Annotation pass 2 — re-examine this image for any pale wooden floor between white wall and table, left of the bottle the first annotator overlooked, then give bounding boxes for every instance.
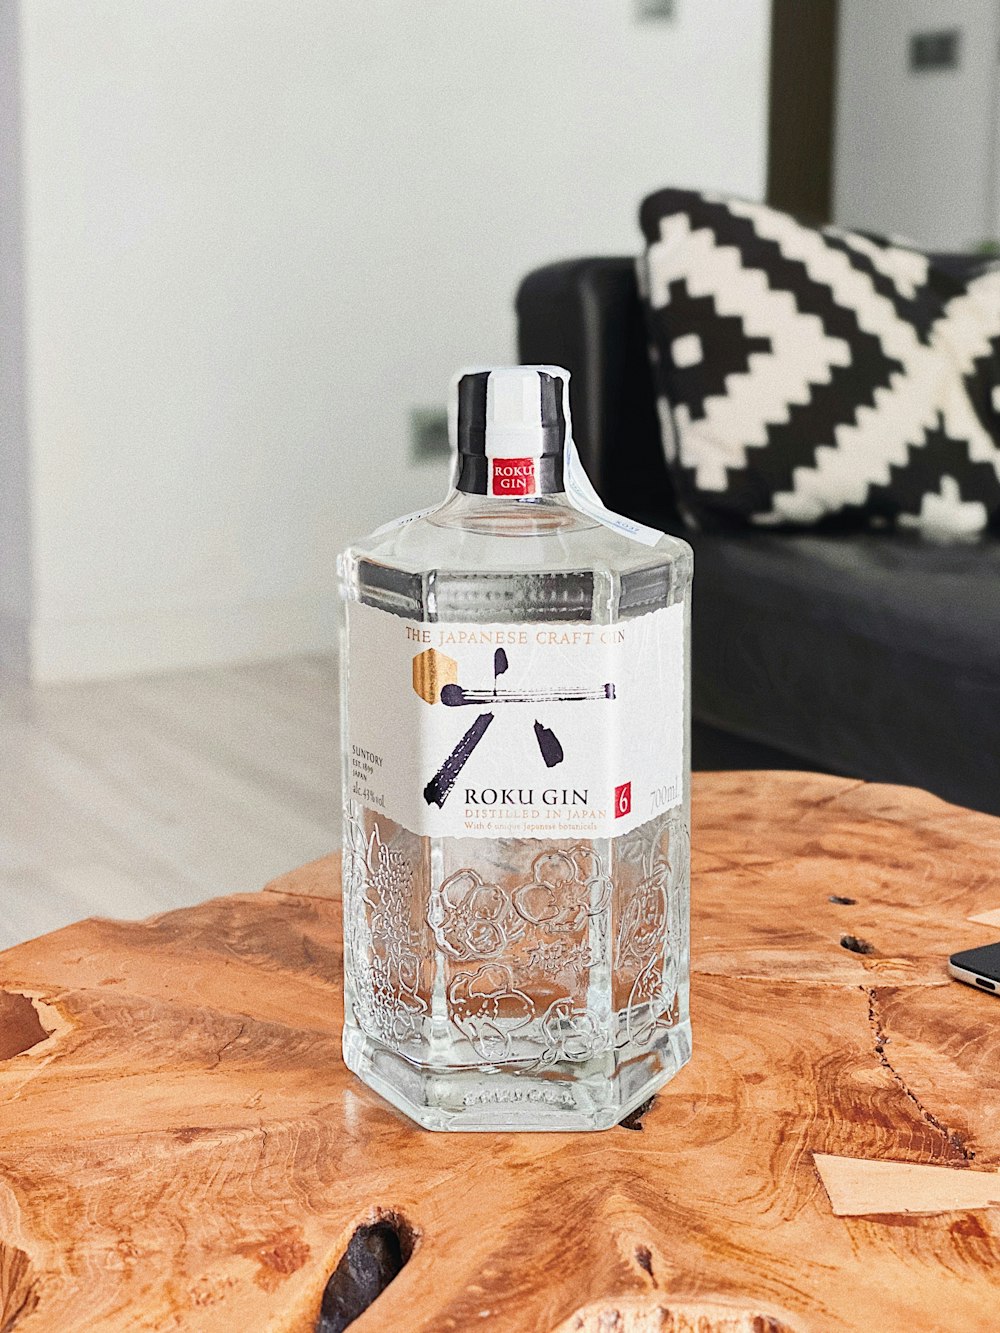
[0,657,340,949]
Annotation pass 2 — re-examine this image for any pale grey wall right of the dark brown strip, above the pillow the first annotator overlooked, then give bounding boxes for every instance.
[833,0,1000,251]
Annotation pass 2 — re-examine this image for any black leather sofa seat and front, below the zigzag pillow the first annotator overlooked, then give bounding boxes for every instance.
[692,532,1000,814]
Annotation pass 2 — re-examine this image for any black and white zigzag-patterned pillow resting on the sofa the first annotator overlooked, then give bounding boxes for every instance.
[640,189,1000,537]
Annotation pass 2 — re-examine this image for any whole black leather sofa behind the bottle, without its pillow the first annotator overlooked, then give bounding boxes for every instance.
[516,259,1000,814]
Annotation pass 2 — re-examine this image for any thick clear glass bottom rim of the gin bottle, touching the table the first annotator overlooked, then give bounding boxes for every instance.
[344,1022,691,1133]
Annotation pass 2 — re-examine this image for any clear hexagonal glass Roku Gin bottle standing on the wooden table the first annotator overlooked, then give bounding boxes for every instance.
[340,367,692,1130]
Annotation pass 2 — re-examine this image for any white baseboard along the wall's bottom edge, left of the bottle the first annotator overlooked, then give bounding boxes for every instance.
[31,592,336,684]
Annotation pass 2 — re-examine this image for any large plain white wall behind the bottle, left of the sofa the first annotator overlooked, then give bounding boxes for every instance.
[11,0,769,680]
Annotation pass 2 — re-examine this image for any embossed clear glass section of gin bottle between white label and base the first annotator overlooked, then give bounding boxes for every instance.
[345,810,689,1070]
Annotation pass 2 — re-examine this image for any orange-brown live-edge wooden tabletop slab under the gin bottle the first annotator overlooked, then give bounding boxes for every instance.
[0,773,1000,1333]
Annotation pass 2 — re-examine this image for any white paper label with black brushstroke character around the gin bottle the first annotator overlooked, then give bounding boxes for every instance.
[347,603,685,838]
